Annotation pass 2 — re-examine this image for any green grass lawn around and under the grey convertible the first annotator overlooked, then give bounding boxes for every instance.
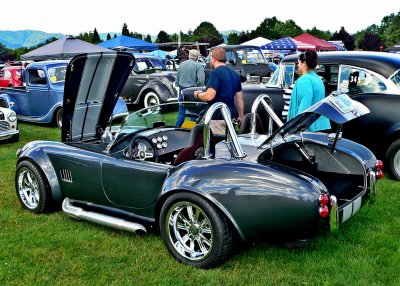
[0,123,400,286]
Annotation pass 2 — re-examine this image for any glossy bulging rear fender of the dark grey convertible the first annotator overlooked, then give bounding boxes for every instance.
[162,159,326,240]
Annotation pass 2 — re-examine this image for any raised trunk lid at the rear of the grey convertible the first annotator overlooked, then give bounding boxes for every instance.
[262,93,369,145]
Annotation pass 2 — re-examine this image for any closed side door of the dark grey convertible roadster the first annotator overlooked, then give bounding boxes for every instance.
[102,157,170,209]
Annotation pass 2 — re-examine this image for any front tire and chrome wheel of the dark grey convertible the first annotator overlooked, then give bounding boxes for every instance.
[15,160,52,214]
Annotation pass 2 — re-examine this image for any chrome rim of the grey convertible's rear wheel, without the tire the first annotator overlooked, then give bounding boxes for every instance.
[166,202,214,261]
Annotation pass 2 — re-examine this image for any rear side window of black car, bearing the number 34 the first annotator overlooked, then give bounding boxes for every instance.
[339,66,387,94]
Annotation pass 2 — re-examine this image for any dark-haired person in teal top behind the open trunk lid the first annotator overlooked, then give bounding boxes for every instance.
[287,50,331,132]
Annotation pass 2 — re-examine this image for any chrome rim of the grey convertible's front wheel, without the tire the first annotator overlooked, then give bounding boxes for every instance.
[17,168,40,209]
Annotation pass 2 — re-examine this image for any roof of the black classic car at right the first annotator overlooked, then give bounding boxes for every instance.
[282,51,400,78]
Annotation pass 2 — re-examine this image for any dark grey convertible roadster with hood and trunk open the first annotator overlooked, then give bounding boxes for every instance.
[15,50,382,268]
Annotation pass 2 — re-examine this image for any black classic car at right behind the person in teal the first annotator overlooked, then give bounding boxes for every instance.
[227,51,400,180]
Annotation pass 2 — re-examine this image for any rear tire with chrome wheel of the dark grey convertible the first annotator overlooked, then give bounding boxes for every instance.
[159,193,234,269]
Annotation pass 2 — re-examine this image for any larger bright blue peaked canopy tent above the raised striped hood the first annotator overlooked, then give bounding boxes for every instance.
[98,35,158,51]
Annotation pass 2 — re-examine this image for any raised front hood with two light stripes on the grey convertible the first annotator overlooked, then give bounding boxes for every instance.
[62,52,135,142]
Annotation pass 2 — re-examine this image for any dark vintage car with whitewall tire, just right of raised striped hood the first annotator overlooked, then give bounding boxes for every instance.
[121,54,178,107]
